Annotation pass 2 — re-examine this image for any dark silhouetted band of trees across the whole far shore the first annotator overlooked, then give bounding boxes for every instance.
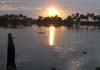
[0,13,100,29]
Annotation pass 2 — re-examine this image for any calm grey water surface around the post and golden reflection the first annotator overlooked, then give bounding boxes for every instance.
[0,26,100,70]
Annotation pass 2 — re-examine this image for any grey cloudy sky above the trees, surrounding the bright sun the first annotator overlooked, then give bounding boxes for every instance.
[0,0,100,18]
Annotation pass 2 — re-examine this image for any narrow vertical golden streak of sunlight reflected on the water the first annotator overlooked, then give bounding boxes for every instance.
[49,26,56,46]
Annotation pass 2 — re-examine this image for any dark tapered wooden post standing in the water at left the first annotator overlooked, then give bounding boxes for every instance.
[7,33,16,70]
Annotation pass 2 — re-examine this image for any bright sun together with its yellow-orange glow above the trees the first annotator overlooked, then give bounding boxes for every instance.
[41,6,71,18]
